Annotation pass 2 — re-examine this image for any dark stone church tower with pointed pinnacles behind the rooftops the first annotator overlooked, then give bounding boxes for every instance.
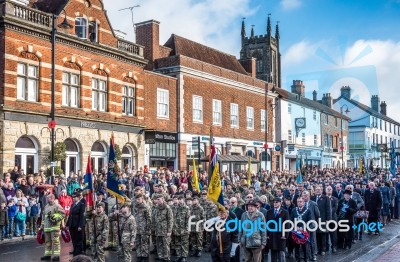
[240,15,281,87]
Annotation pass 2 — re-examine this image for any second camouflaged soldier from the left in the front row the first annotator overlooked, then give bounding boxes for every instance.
[109,203,136,262]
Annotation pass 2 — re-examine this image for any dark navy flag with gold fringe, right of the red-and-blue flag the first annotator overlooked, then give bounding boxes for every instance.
[107,134,125,203]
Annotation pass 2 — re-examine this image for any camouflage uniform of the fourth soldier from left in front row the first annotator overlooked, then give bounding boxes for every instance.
[152,203,174,261]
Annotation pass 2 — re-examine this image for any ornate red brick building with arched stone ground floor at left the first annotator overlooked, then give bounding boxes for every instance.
[0,0,176,174]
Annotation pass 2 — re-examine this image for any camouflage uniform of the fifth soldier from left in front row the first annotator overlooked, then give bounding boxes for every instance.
[173,203,190,258]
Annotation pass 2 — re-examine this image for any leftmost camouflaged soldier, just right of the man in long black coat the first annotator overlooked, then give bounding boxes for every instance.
[90,202,109,262]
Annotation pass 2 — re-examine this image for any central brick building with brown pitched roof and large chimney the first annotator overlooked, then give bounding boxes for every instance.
[136,20,277,170]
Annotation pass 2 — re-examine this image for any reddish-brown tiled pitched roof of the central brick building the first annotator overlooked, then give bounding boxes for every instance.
[164,34,247,75]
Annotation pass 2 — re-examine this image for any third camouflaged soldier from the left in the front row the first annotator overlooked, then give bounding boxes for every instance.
[133,194,151,262]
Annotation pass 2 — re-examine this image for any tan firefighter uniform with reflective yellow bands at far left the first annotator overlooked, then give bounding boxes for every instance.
[41,202,65,261]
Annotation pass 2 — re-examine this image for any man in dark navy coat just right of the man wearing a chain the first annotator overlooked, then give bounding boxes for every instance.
[311,186,332,256]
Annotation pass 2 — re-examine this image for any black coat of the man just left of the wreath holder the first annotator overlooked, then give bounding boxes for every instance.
[265,207,290,251]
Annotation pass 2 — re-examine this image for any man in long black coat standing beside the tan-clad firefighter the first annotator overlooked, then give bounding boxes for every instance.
[67,193,85,256]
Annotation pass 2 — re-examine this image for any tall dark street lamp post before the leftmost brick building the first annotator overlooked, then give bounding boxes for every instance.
[49,9,72,181]
